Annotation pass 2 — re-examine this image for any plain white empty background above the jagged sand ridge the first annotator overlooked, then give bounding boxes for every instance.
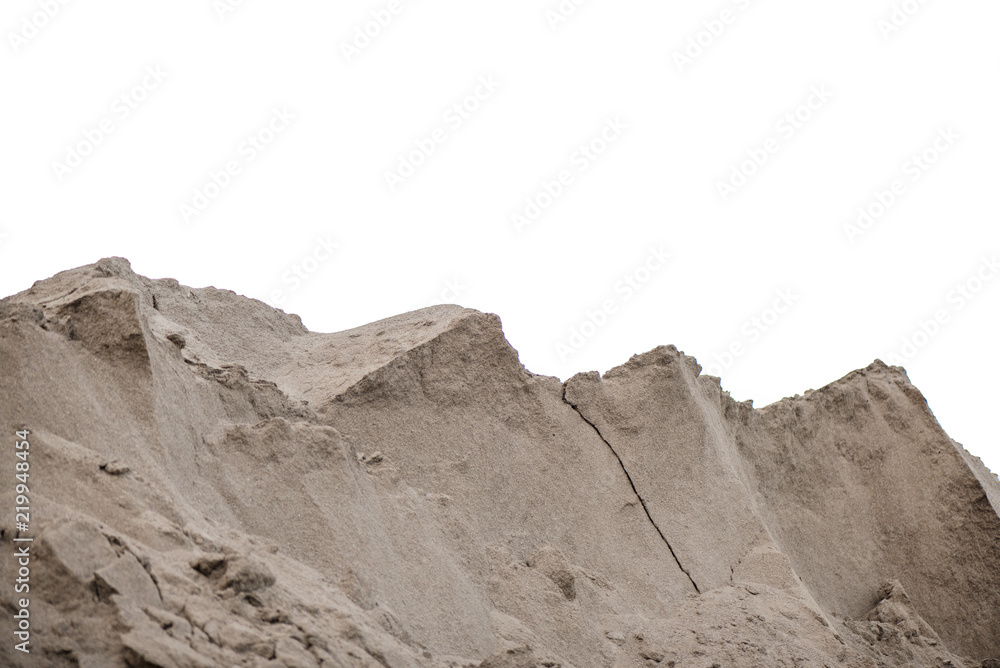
[0,0,1000,471]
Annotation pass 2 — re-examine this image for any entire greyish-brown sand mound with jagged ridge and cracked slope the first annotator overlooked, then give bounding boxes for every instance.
[0,258,1000,668]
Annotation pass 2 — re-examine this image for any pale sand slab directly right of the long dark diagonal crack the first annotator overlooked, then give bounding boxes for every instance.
[566,347,773,591]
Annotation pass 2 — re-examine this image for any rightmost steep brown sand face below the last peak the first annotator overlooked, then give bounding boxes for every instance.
[744,361,1000,656]
